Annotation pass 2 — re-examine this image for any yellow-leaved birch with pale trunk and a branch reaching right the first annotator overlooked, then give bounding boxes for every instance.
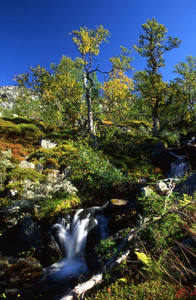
[72,25,132,137]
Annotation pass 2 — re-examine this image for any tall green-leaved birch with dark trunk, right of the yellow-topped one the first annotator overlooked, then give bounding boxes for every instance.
[134,18,181,136]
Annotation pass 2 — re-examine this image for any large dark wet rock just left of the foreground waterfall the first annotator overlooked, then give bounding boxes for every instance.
[0,216,61,267]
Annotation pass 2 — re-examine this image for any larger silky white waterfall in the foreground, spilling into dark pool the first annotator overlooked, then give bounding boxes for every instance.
[44,207,108,284]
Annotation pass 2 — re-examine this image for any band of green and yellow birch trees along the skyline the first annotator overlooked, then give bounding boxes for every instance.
[11,18,196,138]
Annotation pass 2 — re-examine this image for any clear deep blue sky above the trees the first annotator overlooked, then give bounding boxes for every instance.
[0,0,196,86]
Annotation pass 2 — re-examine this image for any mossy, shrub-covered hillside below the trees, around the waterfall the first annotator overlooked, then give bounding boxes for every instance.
[0,106,196,299]
